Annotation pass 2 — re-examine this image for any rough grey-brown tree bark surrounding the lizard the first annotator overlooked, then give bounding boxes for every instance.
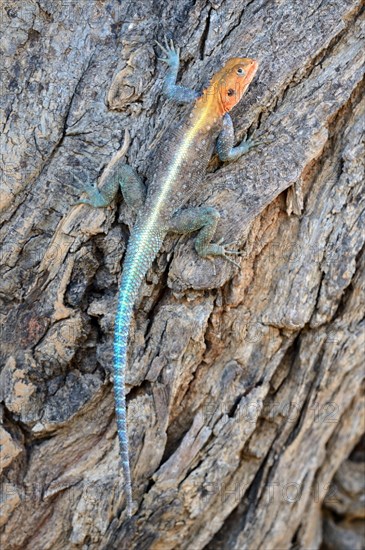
[0,0,364,550]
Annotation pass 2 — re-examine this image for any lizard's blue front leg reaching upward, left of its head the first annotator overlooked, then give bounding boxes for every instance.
[156,38,199,103]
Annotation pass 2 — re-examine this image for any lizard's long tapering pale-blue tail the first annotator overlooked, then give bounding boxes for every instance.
[114,227,163,517]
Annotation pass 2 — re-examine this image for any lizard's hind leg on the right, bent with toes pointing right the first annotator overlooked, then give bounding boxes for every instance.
[169,206,240,268]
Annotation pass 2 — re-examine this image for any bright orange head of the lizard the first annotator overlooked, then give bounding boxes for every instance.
[203,57,258,117]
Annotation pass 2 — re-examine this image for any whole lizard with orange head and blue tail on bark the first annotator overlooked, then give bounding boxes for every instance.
[78,37,260,517]
